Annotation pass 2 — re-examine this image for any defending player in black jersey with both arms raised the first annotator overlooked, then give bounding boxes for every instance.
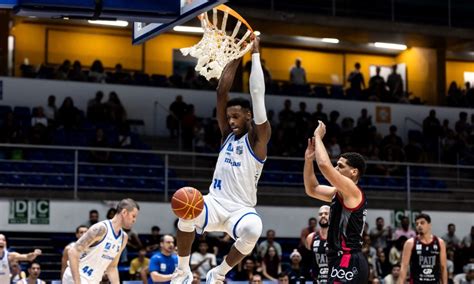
[304,121,369,284]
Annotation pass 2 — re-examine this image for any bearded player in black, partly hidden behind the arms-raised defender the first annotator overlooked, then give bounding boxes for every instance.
[306,205,330,284]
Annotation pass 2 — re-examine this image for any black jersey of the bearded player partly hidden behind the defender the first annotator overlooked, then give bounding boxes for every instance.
[311,234,329,284]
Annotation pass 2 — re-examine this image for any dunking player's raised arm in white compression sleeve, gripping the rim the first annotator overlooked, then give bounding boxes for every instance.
[249,37,272,160]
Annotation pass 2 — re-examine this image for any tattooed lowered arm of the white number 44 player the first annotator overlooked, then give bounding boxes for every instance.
[68,223,107,282]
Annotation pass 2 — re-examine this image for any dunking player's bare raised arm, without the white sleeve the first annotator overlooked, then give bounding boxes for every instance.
[216,59,240,141]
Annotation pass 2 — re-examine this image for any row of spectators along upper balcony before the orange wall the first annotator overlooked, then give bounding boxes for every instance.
[16,59,474,107]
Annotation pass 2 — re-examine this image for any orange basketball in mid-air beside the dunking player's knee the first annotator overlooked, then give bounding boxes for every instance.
[171,187,204,220]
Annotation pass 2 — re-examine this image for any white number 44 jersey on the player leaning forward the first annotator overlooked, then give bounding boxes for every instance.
[74,220,124,283]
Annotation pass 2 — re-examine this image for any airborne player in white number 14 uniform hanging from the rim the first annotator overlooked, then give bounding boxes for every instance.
[171,38,271,284]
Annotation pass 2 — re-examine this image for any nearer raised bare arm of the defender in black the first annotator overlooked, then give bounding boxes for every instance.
[314,121,362,207]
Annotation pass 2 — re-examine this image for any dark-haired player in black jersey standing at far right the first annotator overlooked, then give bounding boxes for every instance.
[398,214,448,284]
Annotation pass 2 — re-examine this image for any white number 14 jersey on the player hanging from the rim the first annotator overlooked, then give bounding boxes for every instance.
[209,133,265,211]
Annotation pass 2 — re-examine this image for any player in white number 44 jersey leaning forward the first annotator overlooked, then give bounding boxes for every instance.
[62,199,140,284]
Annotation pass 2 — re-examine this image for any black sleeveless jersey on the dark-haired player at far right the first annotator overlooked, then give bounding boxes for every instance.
[410,236,441,284]
